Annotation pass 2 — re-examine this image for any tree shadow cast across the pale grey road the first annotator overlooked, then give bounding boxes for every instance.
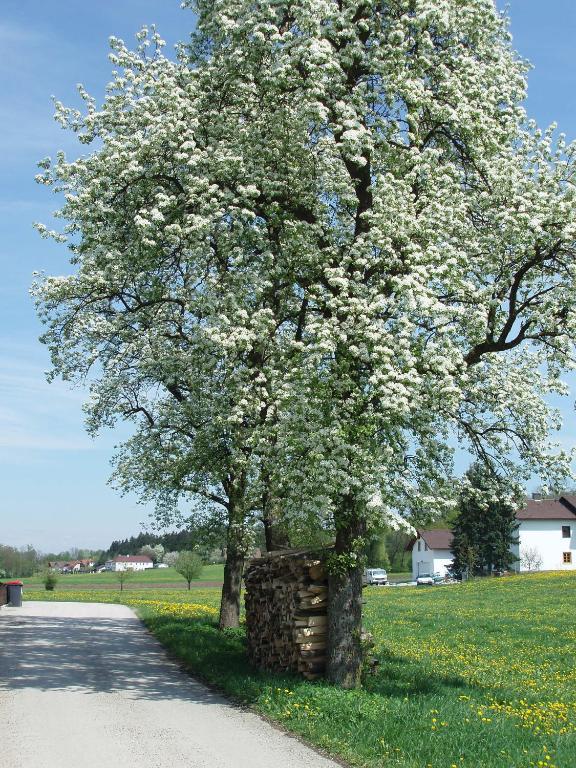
[0,612,222,704]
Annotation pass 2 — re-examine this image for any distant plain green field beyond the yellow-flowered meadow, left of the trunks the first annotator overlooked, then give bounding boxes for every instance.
[22,564,224,590]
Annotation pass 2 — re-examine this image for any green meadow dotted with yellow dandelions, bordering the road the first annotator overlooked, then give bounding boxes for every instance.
[20,573,576,768]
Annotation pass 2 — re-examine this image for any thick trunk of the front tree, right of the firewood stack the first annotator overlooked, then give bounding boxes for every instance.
[326,499,365,688]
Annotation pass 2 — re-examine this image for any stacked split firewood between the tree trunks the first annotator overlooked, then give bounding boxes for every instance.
[244,550,328,680]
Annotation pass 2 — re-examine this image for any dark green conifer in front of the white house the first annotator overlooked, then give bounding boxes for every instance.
[452,462,520,576]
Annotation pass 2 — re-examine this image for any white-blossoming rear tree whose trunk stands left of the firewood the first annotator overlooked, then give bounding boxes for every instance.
[35,31,298,627]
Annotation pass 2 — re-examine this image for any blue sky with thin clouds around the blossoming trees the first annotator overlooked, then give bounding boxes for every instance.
[0,0,576,551]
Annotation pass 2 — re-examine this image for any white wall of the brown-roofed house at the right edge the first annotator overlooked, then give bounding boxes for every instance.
[512,518,576,571]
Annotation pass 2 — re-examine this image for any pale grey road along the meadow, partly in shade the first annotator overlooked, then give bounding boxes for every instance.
[0,602,337,768]
